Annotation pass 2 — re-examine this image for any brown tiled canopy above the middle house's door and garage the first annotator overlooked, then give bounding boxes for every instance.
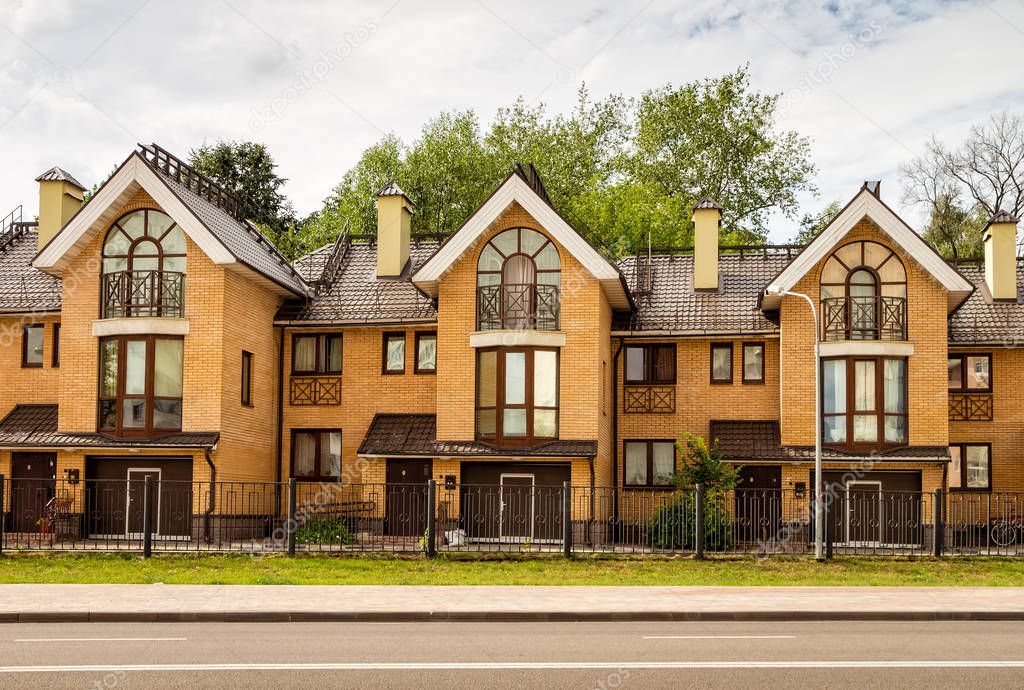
[357,414,597,458]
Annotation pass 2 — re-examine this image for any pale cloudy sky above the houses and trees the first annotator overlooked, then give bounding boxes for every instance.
[0,0,1024,242]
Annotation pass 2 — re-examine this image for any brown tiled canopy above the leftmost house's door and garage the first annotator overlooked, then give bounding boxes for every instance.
[0,404,220,448]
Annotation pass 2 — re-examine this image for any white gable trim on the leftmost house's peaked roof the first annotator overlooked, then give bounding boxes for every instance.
[32,154,237,274]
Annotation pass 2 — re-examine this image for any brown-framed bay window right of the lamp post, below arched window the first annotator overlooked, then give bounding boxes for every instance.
[821,357,907,450]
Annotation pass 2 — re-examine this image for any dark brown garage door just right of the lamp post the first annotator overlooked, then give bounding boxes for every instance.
[811,464,924,546]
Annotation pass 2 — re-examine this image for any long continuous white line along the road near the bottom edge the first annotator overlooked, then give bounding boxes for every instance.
[0,659,1024,674]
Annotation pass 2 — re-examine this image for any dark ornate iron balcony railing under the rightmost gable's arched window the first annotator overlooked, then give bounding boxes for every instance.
[821,296,906,341]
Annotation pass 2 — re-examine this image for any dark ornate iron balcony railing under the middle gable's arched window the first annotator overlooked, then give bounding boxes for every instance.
[476,284,561,331]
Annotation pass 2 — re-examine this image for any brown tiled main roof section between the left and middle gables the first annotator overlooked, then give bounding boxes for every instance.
[278,242,439,324]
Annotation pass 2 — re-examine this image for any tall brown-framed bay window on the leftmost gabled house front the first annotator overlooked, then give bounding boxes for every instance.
[98,336,184,437]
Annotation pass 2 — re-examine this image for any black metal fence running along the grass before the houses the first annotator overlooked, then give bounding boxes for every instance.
[0,472,1024,556]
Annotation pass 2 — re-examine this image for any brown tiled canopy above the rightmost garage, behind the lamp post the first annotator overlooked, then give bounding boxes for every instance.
[711,420,949,462]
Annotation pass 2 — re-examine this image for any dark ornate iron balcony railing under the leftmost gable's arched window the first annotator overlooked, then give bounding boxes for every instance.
[102,270,185,318]
